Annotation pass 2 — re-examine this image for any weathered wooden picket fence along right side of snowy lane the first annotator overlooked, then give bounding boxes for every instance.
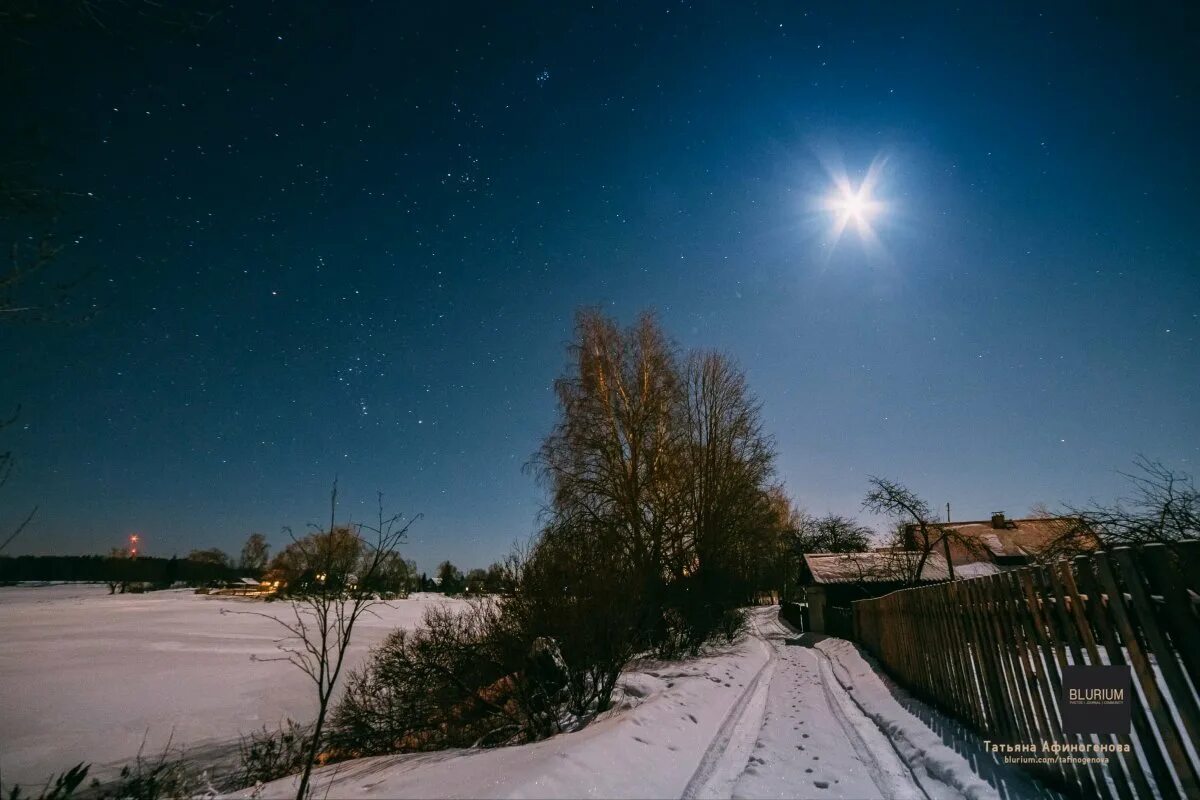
[853,542,1200,800]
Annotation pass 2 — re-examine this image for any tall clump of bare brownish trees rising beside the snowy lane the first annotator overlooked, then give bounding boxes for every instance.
[530,309,784,642]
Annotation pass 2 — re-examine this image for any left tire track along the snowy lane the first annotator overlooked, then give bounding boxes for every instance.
[682,614,779,800]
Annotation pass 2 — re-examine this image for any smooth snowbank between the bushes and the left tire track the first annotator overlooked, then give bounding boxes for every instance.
[224,638,768,799]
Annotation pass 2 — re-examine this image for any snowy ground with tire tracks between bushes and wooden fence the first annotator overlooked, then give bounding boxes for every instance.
[225,607,1052,800]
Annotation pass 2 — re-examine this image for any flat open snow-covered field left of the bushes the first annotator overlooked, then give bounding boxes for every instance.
[0,584,462,784]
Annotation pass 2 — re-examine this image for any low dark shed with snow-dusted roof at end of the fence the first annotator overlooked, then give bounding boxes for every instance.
[799,548,950,636]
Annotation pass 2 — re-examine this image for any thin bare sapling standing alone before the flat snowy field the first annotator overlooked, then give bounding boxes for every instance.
[229,481,421,800]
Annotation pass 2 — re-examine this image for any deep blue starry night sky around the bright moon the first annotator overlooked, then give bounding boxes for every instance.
[0,1,1200,569]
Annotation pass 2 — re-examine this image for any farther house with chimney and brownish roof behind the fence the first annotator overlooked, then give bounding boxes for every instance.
[904,511,1099,578]
